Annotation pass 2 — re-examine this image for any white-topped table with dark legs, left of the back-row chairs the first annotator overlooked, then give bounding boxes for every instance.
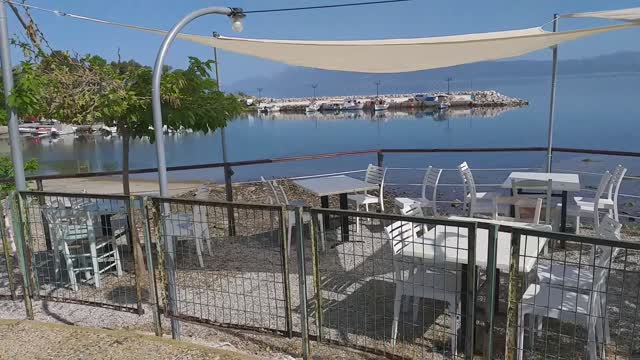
[294,175,378,241]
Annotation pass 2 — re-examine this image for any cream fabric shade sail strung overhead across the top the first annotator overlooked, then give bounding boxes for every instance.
[66,8,640,73]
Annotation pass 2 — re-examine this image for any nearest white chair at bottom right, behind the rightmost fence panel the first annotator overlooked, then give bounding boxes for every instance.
[518,215,622,359]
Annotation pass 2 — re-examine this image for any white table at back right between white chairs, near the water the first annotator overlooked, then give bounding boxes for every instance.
[502,172,580,232]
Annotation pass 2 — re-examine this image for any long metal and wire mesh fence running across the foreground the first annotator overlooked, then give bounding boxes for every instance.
[0,192,640,359]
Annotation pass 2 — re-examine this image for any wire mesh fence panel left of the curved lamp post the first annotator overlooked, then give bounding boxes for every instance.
[21,192,142,311]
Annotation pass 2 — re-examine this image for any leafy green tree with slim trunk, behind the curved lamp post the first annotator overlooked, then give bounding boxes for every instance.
[0,42,243,193]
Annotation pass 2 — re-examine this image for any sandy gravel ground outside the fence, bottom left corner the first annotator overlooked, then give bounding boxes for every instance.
[0,320,255,360]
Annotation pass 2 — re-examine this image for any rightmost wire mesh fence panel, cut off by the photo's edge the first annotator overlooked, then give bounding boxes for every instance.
[508,225,640,359]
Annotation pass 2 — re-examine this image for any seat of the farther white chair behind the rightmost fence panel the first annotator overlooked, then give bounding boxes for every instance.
[537,262,593,291]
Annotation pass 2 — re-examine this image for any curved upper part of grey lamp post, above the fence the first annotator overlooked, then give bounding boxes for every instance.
[151,7,243,196]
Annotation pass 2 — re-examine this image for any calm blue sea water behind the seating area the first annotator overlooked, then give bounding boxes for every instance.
[0,74,640,191]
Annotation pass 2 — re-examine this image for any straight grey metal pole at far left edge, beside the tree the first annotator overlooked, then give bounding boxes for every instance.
[0,4,27,191]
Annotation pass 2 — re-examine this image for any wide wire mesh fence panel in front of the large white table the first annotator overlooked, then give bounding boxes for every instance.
[307,209,476,359]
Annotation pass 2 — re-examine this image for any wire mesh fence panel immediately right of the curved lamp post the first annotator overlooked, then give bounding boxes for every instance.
[153,198,294,332]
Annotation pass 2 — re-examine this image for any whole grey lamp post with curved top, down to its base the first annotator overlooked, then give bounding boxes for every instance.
[150,7,245,339]
